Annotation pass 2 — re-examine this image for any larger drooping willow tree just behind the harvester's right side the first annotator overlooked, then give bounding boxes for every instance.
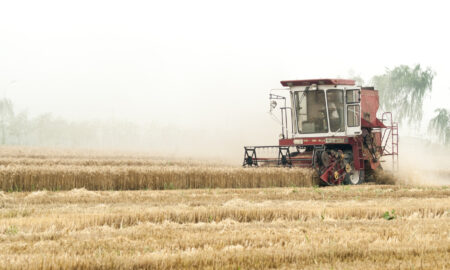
[372,65,435,124]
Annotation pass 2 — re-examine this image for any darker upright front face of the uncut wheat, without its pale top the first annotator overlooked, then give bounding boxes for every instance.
[0,165,314,191]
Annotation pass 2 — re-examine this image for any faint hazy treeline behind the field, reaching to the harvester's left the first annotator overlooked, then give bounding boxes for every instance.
[0,98,243,161]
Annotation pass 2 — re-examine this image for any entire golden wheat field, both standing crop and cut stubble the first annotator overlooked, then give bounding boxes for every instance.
[0,148,450,269]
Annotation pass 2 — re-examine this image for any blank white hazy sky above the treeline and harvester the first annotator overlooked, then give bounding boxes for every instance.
[0,0,450,131]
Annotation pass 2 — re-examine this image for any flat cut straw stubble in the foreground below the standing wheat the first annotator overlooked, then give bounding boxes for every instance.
[0,186,450,269]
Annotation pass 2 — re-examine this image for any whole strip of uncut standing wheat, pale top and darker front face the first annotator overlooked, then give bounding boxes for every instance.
[0,148,316,191]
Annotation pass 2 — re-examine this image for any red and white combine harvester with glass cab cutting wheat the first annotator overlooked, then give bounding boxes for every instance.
[243,79,398,185]
